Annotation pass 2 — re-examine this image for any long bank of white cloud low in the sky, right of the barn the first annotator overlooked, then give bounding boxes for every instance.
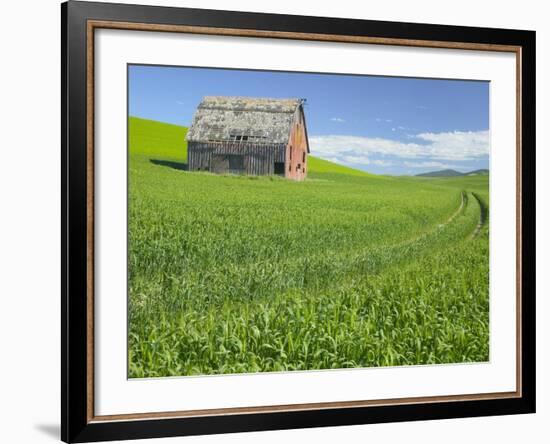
[309,131,489,161]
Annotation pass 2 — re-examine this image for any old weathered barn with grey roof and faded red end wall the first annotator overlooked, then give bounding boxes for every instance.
[187,96,309,180]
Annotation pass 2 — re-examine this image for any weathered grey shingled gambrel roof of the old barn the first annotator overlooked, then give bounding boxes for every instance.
[187,96,304,144]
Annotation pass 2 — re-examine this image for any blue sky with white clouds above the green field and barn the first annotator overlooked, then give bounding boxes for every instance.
[129,65,489,174]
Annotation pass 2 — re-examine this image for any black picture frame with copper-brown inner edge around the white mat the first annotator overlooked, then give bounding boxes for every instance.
[61,1,536,442]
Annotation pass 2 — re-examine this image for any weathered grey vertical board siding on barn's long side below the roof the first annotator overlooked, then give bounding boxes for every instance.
[187,142,285,176]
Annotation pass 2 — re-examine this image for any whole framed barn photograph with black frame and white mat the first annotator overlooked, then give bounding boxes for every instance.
[61,1,535,442]
